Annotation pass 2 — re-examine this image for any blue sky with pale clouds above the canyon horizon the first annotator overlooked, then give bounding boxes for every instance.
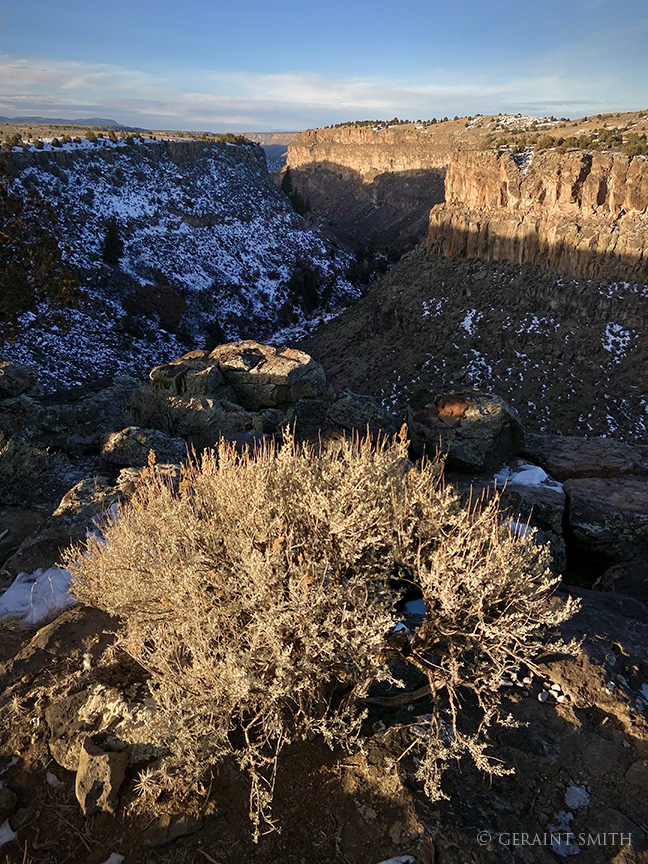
[0,0,648,132]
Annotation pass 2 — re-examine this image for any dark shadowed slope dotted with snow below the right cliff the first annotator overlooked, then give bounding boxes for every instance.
[302,247,648,442]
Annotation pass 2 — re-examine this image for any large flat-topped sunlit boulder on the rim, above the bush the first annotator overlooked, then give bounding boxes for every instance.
[209,340,333,411]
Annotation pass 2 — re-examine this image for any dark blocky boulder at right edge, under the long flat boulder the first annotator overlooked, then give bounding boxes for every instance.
[565,476,648,566]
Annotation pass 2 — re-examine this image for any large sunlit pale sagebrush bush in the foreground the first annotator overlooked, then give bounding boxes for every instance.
[68,430,571,836]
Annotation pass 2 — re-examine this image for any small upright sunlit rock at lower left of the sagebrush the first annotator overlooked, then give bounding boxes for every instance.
[74,737,128,816]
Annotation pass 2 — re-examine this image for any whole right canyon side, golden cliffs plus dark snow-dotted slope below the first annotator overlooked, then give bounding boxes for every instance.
[287,118,648,440]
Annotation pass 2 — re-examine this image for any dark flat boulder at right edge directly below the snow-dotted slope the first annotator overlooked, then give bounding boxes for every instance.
[524,435,648,483]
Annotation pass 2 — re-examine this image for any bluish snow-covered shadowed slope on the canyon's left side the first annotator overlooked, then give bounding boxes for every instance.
[3,139,356,386]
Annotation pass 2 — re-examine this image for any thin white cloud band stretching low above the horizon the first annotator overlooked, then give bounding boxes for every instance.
[0,55,640,130]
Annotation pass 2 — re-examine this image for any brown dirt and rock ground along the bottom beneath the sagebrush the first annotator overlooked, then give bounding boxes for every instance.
[0,589,648,864]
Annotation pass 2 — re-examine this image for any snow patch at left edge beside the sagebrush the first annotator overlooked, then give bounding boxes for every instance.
[0,567,76,626]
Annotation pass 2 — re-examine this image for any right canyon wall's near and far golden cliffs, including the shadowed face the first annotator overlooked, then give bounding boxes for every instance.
[283,123,648,282]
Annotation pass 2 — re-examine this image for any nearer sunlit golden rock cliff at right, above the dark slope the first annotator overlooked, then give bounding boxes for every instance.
[427,150,648,282]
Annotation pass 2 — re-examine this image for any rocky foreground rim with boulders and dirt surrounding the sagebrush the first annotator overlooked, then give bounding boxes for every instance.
[0,342,648,864]
